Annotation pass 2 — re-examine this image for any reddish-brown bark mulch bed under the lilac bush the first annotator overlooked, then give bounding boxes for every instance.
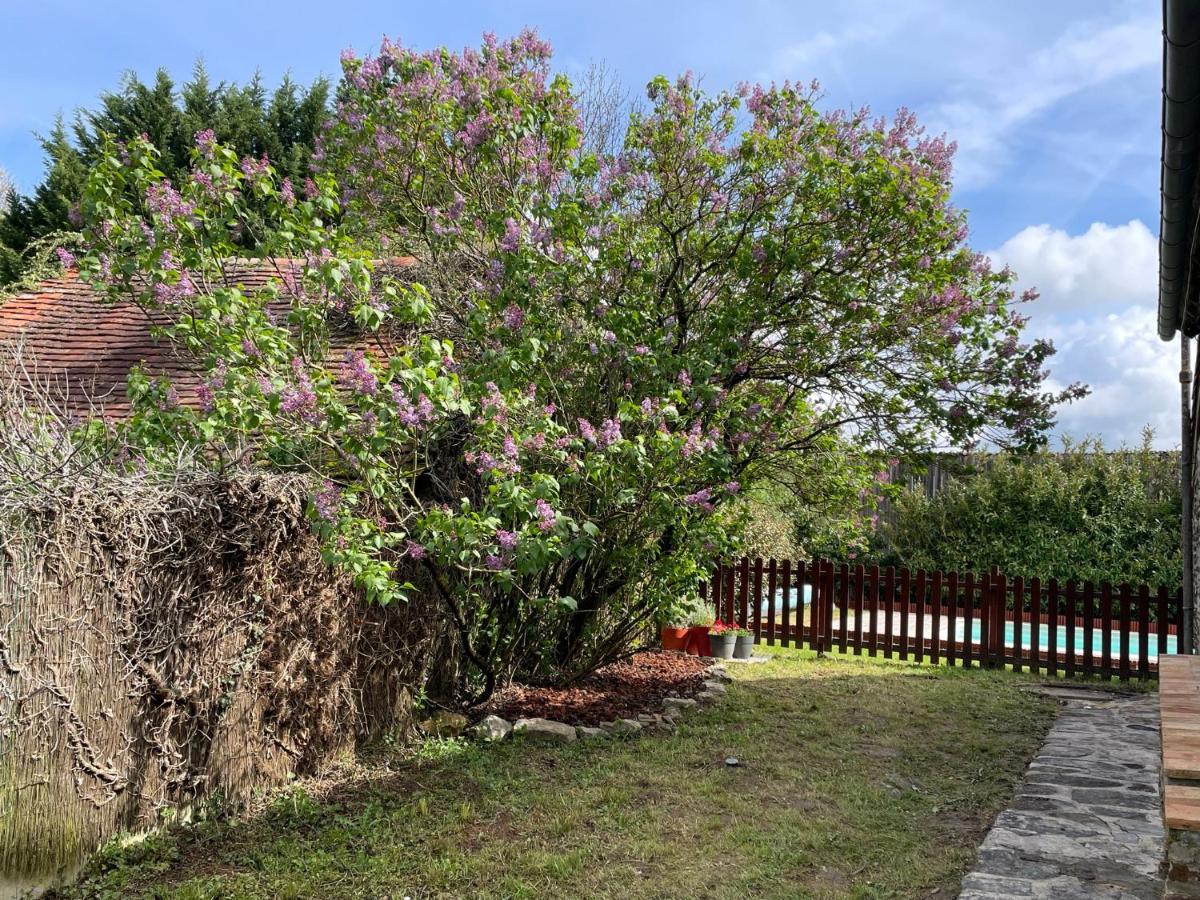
[486,653,712,726]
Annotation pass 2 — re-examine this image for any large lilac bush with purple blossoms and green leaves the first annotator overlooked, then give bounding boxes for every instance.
[80,32,1081,700]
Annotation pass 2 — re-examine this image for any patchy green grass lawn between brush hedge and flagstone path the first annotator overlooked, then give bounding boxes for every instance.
[58,649,1054,900]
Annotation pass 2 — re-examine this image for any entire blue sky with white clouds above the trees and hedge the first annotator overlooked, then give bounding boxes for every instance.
[0,0,1178,445]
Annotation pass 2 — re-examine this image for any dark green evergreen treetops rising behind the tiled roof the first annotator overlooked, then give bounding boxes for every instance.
[0,62,330,284]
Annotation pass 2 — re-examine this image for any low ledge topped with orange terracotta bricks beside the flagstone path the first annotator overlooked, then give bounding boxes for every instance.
[1158,655,1200,898]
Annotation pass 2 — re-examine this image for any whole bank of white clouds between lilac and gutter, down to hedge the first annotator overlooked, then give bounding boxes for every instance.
[989,220,1180,448]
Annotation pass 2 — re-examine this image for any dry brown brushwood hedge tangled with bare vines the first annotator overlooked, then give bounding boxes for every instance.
[0,352,452,878]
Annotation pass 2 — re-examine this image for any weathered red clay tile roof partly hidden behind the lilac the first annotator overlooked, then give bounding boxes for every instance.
[0,257,415,418]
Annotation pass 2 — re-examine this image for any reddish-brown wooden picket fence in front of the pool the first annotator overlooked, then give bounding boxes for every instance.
[701,559,1183,680]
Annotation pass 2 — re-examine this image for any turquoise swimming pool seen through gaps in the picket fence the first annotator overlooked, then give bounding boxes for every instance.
[760,584,1178,660]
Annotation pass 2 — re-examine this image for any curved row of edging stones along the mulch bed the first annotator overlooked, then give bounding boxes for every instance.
[470,662,733,744]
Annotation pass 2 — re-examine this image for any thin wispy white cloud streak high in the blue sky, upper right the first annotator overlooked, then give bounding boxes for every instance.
[930,17,1162,188]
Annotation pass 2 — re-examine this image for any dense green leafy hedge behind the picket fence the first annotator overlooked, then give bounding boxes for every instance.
[877,432,1183,588]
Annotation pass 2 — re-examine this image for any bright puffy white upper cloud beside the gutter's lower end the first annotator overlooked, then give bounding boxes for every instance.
[989,218,1158,313]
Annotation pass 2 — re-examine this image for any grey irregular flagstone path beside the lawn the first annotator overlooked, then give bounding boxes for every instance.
[959,691,1164,900]
